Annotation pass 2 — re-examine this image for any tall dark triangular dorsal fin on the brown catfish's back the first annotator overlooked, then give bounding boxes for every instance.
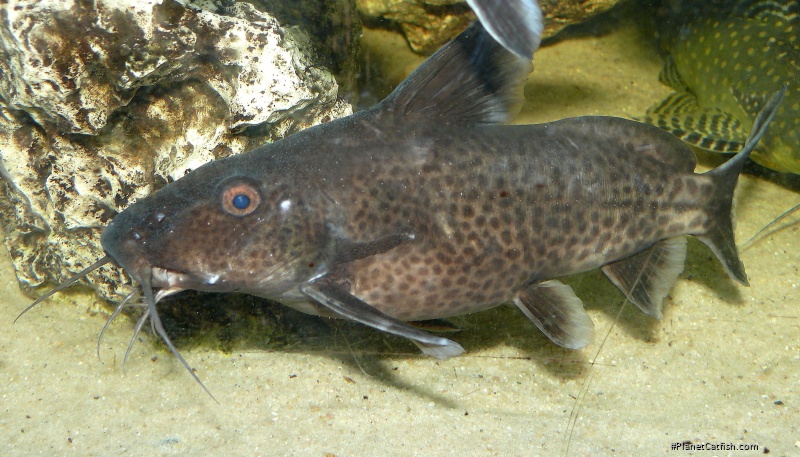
[375,22,531,125]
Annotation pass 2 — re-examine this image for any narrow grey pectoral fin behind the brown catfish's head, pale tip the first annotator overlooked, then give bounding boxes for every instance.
[300,278,464,360]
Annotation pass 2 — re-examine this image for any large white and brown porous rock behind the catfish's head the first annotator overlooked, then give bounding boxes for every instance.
[0,0,360,300]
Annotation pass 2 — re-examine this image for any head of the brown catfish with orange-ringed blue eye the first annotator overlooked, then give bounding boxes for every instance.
[101,146,335,301]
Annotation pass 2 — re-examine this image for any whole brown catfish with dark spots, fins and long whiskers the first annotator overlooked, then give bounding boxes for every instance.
[18,14,783,392]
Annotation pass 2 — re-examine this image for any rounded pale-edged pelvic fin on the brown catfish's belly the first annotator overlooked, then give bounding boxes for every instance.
[513,280,594,349]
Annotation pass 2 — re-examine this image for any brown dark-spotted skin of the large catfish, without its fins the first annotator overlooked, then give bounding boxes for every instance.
[106,116,692,306]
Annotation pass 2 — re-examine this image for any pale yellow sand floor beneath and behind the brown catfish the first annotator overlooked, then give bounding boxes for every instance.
[0,16,800,457]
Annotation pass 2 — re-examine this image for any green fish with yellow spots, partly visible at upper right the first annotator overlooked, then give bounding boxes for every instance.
[645,0,800,173]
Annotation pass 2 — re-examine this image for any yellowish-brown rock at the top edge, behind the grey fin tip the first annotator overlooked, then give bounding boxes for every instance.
[356,0,621,55]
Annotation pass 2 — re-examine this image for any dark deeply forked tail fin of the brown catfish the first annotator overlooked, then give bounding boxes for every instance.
[698,86,786,286]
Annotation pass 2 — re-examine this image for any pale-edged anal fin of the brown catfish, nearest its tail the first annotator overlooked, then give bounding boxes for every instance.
[601,236,686,319]
